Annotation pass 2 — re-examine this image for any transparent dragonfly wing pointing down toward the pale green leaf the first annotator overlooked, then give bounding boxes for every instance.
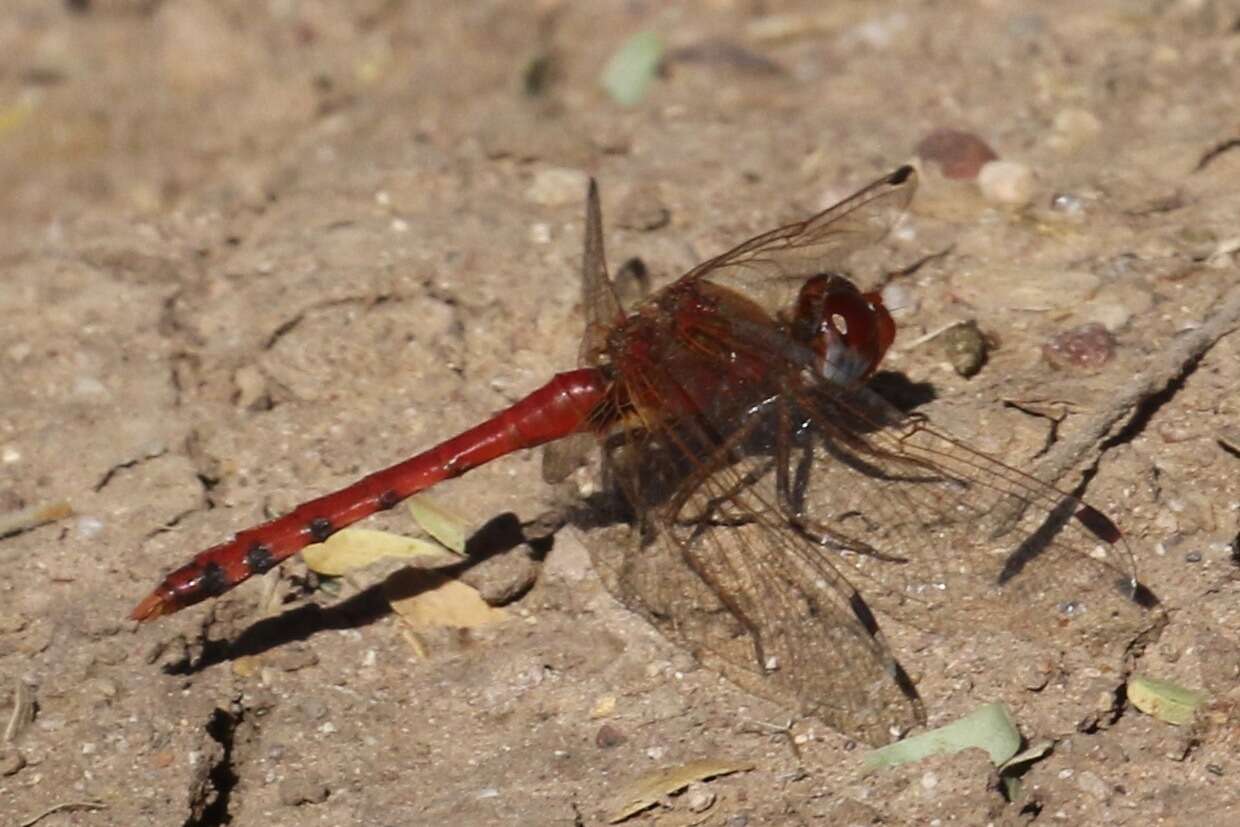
[591,389,925,744]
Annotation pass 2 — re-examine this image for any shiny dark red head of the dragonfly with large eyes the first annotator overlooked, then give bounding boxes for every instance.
[792,273,895,387]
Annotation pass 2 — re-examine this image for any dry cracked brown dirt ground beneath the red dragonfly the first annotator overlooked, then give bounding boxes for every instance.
[0,0,1240,827]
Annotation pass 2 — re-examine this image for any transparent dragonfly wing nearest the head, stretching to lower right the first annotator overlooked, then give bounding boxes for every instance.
[789,386,1149,642]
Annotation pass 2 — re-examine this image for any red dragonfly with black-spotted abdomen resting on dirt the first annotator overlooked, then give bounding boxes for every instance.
[131,166,1152,743]
